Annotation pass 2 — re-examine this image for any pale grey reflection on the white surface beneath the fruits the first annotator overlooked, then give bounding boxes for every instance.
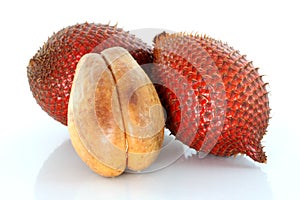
[35,140,272,200]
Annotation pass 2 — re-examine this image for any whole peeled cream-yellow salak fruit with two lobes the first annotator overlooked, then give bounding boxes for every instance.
[68,47,164,177]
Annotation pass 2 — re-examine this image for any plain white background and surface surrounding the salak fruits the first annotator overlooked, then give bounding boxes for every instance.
[0,0,300,199]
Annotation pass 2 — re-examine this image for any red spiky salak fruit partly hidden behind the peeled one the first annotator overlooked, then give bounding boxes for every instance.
[27,23,152,125]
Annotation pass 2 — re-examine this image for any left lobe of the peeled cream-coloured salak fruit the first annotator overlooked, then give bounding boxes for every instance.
[68,54,126,176]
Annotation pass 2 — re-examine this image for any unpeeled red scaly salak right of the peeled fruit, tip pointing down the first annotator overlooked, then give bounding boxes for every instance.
[149,33,270,163]
